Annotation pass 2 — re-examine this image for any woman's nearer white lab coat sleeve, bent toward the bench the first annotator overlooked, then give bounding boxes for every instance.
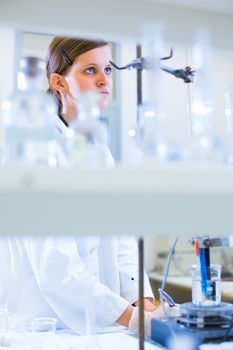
[24,237,129,334]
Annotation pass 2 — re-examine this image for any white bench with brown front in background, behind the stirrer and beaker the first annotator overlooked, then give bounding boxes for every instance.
[148,272,233,304]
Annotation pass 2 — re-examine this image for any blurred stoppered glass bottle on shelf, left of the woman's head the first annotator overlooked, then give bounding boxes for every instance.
[1,57,57,167]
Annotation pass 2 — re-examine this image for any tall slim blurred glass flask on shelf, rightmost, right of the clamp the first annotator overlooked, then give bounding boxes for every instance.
[190,29,226,163]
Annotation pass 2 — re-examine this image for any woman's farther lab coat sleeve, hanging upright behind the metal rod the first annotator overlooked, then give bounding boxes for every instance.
[118,237,154,304]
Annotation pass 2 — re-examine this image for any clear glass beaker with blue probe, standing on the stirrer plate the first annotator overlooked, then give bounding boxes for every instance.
[192,264,222,306]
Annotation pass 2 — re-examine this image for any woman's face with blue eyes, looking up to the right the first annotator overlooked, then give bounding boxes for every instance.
[65,45,112,109]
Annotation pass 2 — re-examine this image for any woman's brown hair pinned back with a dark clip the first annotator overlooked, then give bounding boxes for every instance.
[46,36,108,120]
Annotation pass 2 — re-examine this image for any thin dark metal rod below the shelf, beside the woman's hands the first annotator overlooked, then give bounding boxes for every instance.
[138,238,145,350]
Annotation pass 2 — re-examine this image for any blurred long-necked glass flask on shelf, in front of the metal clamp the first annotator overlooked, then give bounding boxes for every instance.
[129,23,182,166]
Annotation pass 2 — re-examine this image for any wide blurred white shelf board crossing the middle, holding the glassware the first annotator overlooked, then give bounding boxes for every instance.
[0,164,233,236]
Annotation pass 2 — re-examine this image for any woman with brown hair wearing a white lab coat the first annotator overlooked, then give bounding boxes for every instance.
[4,37,177,335]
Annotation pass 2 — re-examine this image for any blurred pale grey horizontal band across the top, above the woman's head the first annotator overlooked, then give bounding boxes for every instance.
[0,0,233,48]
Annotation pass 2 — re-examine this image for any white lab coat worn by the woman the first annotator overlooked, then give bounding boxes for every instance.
[0,114,156,334]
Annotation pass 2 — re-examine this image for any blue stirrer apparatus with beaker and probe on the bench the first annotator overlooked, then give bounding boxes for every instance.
[151,236,233,348]
